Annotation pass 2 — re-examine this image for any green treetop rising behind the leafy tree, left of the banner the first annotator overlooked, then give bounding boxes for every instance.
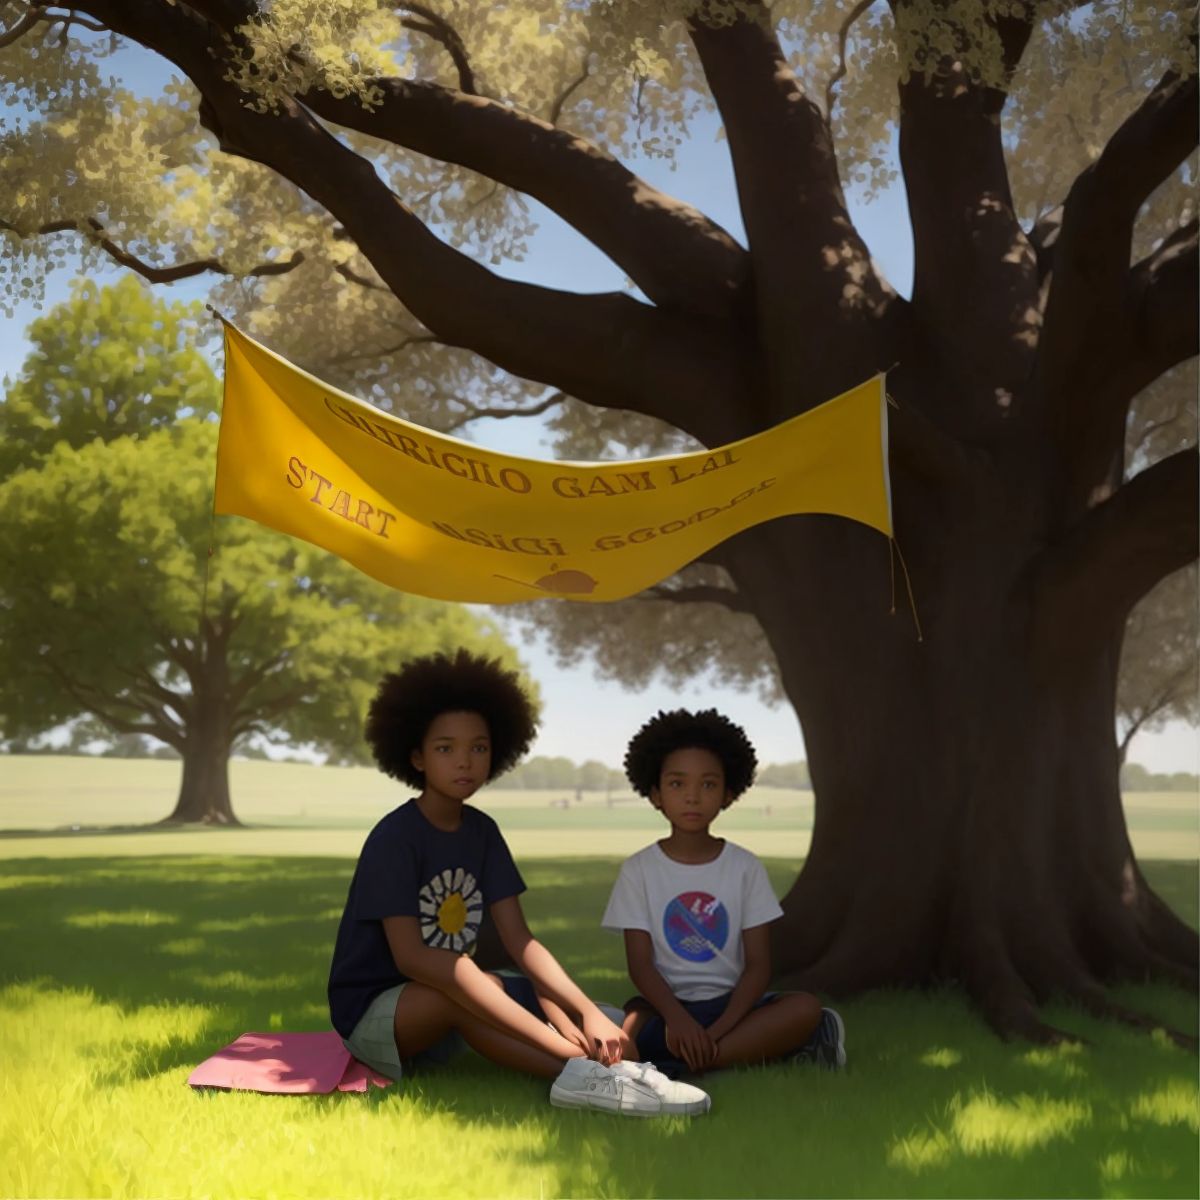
[0,275,220,479]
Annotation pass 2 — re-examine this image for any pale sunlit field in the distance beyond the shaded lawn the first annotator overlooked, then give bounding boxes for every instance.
[0,755,1200,860]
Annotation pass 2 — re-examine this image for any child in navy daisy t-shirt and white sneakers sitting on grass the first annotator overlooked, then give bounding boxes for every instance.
[329,650,709,1116]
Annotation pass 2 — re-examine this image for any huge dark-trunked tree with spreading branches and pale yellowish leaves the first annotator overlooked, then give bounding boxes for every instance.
[0,0,1198,1039]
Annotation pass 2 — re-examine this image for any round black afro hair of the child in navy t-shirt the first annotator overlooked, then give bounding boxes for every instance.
[366,650,538,787]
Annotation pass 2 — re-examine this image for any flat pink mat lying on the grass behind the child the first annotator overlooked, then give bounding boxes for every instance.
[187,1030,391,1096]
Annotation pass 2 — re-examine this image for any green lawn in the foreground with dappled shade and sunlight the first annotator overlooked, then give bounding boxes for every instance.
[0,854,1200,1198]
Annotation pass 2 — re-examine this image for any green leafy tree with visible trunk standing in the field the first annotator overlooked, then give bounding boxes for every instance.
[0,421,525,824]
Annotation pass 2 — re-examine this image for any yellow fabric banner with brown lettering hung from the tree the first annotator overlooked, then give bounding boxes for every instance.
[216,325,892,604]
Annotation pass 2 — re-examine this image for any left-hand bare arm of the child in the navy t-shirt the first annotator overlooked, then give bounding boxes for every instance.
[383,917,578,1058]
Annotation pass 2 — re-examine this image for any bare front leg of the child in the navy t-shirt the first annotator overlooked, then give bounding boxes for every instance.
[392,983,582,1079]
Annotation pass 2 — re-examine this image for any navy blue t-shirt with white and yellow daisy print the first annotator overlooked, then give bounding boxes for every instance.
[329,800,524,1038]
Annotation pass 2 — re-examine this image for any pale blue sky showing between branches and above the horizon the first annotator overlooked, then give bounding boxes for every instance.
[0,37,1200,772]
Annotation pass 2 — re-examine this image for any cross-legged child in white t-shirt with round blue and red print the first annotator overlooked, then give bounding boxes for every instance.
[604,709,846,1072]
